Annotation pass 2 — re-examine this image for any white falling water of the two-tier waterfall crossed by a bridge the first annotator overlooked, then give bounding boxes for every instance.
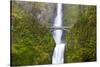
[52,3,65,64]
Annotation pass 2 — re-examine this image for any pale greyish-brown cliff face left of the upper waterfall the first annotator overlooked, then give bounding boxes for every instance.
[16,1,56,27]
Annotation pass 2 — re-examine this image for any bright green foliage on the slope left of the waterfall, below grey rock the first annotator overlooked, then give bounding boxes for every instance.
[11,2,54,66]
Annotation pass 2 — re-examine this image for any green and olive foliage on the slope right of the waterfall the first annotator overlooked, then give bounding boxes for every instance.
[65,6,96,62]
